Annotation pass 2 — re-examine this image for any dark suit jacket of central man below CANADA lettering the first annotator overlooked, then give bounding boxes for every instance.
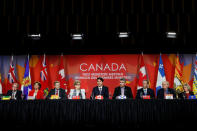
[90,86,109,99]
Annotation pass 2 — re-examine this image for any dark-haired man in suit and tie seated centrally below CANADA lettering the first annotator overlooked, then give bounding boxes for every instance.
[90,77,109,99]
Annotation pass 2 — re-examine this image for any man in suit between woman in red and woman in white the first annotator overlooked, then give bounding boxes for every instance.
[47,81,67,99]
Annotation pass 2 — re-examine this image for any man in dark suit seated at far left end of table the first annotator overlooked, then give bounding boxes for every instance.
[6,82,22,100]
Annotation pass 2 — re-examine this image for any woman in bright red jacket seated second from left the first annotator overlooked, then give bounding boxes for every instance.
[28,82,44,100]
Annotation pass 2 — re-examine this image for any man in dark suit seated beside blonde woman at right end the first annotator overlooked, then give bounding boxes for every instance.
[157,81,176,99]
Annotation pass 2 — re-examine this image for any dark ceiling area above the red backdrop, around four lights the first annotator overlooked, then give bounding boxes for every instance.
[0,0,197,54]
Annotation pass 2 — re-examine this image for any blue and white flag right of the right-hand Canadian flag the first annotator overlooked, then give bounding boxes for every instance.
[156,55,166,95]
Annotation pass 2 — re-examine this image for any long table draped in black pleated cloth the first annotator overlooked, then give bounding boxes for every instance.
[0,100,197,128]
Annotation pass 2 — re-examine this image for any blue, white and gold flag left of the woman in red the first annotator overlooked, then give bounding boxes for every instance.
[21,56,32,99]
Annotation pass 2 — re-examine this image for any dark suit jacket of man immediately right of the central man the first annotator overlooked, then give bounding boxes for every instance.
[113,86,133,99]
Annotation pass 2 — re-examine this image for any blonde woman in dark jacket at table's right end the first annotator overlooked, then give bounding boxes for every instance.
[178,83,194,99]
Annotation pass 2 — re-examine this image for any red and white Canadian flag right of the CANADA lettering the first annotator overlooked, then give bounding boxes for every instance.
[137,55,147,89]
